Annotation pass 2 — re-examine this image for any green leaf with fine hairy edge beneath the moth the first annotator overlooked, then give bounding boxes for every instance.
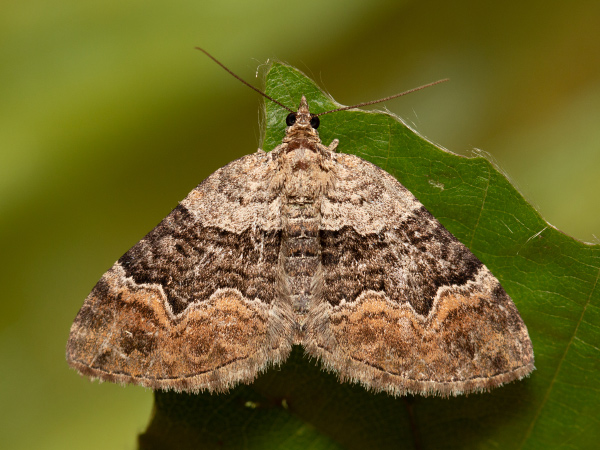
[140,64,600,449]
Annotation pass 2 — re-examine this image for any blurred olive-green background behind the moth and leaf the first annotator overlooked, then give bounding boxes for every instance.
[0,0,600,449]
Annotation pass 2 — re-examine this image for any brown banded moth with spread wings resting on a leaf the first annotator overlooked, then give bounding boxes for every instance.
[67,50,534,396]
